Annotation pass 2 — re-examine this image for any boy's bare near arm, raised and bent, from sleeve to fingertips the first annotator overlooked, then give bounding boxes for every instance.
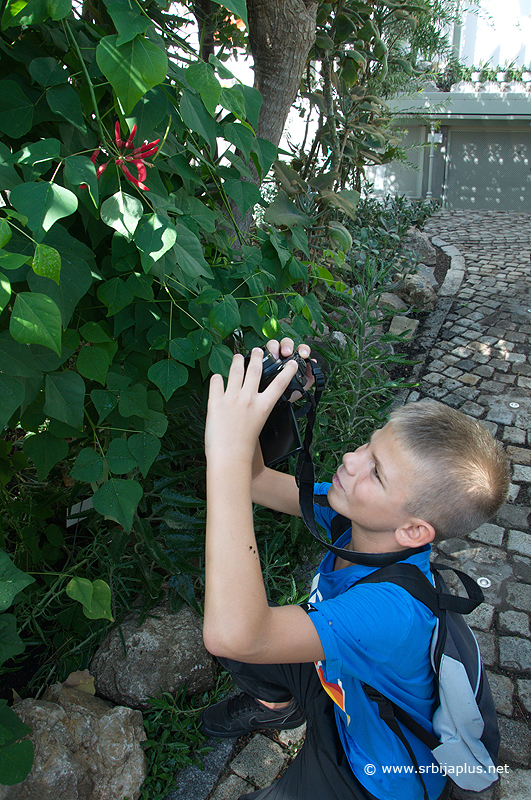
[203,350,324,663]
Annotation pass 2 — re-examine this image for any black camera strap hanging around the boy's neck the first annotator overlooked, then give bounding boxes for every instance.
[295,361,424,567]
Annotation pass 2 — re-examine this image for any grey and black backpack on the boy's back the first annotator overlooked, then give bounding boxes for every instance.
[358,563,500,800]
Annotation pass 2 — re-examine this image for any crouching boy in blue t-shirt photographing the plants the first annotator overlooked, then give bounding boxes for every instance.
[202,339,508,800]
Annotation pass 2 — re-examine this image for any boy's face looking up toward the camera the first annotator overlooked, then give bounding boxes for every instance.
[328,425,415,534]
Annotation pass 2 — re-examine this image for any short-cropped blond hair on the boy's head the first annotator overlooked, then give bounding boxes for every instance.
[389,400,510,539]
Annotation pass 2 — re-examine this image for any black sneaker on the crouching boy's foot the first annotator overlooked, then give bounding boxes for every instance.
[201,693,304,737]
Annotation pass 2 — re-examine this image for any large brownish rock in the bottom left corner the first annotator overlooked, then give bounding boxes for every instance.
[0,684,147,800]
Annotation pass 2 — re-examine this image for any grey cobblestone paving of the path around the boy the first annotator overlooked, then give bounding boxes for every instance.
[167,211,531,800]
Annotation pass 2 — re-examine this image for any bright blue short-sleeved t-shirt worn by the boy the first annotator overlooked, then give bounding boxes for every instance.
[309,483,446,800]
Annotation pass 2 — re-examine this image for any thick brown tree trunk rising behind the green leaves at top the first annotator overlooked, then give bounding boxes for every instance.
[247,0,318,145]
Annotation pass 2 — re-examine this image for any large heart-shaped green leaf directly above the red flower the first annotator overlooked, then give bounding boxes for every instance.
[96,36,168,114]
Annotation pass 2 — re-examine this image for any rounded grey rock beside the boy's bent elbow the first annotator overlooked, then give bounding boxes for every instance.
[90,601,214,709]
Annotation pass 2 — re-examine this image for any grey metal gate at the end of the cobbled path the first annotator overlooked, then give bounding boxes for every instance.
[444,127,531,211]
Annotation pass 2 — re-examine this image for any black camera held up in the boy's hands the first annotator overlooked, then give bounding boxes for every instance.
[245,347,307,467]
